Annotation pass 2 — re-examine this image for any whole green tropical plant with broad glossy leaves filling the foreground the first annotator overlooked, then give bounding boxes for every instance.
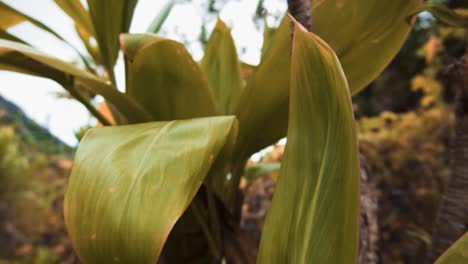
[0,0,464,263]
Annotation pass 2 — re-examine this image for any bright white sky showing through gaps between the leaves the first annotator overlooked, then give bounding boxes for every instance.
[0,0,287,146]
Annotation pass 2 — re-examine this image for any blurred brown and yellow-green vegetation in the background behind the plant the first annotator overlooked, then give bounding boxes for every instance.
[0,1,464,264]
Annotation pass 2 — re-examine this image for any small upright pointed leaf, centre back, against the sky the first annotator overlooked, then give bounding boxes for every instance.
[201,19,243,115]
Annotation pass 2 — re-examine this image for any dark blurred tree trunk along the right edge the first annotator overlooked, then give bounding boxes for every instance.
[426,38,468,263]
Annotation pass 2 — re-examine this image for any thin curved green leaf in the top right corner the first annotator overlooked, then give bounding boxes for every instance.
[409,1,468,28]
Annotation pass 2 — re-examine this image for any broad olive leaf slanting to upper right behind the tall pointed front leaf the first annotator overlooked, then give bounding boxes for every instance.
[236,0,421,161]
